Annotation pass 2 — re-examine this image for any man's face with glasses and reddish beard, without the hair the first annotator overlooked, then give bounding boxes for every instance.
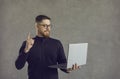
[37,19,51,37]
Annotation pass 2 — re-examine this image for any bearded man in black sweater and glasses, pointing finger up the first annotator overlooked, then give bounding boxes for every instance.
[15,15,79,79]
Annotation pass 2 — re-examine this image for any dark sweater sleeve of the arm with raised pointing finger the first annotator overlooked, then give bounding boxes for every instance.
[15,41,29,70]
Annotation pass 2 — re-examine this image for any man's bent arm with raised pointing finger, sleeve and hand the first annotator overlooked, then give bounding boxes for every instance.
[15,33,34,69]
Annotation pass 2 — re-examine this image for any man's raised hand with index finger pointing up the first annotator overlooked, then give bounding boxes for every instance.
[24,33,34,53]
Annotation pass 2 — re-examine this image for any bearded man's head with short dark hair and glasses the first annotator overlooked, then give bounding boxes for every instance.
[35,15,51,37]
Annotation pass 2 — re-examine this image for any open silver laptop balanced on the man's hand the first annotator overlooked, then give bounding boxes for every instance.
[49,43,88,69]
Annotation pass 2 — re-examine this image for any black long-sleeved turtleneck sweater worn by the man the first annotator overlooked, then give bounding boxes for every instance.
[15,36,67,79]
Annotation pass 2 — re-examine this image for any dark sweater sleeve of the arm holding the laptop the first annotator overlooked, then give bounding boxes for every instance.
[57,41,69,73]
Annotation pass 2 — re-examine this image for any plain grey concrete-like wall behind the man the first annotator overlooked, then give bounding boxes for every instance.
[0,0,120,79]
